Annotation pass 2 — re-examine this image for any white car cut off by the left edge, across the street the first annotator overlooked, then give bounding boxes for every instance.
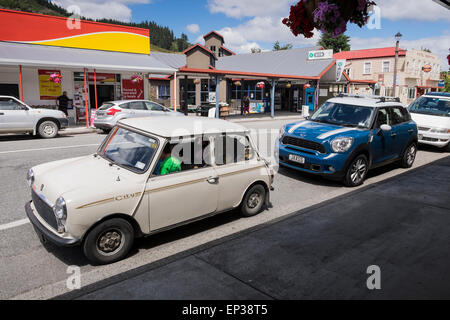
[0,96,69,138]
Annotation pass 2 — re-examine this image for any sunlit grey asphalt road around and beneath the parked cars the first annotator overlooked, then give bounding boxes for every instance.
[0,120,448,299]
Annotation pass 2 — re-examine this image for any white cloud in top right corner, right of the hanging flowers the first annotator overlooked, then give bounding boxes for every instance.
[375,0,450,21]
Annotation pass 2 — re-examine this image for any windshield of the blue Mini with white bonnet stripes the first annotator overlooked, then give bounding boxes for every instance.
[311,102,374,128]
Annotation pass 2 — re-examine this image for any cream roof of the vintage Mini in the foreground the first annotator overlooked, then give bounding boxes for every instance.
[120,116,248,138]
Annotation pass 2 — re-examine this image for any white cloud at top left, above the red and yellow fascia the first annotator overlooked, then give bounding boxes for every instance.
[52,0,151,22]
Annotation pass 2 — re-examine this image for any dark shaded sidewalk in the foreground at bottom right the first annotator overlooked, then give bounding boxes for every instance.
[57,157,450,300]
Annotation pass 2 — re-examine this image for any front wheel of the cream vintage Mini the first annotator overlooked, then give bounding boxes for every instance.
[83,218,134,264]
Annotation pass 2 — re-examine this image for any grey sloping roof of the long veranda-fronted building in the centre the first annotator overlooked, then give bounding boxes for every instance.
[216,47,334,78]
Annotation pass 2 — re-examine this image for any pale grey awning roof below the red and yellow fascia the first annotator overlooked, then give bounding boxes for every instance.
[0,41,176,74]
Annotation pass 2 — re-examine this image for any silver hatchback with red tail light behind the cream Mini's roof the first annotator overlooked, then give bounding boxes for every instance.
[94,100,184,132]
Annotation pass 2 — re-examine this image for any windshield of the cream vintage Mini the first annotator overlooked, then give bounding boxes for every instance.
[99,128,158,173]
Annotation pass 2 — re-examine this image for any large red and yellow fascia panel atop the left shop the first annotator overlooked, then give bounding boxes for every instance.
[0,9,150,54]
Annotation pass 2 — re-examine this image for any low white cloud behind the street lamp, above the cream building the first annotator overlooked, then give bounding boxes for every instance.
[351,33,450,70]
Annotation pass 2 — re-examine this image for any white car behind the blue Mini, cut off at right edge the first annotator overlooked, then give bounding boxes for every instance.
[409,92,450,151]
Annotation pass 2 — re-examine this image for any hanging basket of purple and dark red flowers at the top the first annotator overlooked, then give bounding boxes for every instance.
[282,0,375,38]
